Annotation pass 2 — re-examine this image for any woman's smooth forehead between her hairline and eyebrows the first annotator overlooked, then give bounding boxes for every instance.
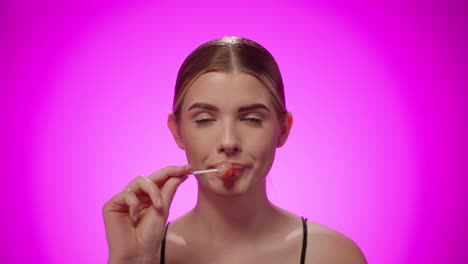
[182,72,273,110]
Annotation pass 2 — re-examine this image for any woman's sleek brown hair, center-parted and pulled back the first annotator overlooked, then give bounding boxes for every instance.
[173,37,287,119]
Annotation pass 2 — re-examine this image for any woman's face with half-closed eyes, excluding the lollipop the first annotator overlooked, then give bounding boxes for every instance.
[169,72,290,195]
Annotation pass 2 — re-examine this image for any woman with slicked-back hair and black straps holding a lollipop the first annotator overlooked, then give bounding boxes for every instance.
[103,37,366,264]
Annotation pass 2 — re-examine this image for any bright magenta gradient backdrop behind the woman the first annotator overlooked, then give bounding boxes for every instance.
[0,0,467,263]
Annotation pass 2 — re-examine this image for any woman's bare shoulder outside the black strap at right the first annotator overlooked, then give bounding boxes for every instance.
[306,221,367,264]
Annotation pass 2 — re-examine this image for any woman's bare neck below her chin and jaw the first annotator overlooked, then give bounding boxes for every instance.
[193,179,277,241]
